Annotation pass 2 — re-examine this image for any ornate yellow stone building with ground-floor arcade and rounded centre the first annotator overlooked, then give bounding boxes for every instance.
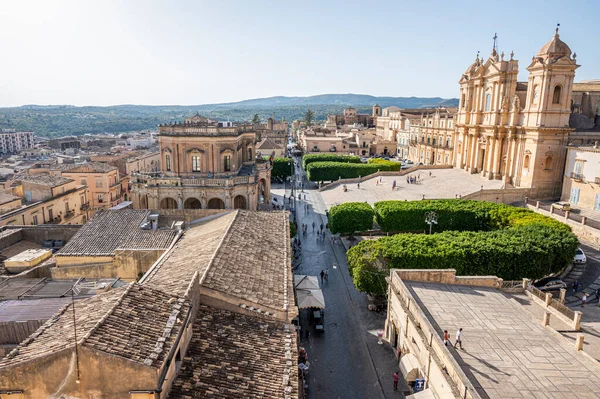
[131,115,271,210]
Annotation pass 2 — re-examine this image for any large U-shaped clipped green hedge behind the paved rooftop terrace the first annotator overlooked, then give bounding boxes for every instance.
[347,200,579,295]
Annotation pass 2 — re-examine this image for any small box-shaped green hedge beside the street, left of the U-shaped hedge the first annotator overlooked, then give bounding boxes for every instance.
[328,202,375,234]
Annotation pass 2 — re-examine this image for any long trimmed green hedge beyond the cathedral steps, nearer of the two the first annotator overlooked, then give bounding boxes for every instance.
[306,162,400,181]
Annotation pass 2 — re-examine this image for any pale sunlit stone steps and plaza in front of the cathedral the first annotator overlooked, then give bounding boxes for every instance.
[321,169,504,208]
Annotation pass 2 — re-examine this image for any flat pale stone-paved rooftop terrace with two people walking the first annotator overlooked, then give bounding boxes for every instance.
[405,281,600,399]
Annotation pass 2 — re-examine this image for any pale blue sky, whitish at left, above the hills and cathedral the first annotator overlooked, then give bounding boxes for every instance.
[0,0,600,106]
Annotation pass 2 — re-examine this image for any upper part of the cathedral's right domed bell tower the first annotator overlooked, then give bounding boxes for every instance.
[523,27,579,128]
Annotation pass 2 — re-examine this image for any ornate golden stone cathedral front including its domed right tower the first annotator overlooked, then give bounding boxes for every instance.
[453,29,578,198]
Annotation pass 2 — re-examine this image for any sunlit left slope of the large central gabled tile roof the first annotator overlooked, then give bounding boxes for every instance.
[142,212,235,296]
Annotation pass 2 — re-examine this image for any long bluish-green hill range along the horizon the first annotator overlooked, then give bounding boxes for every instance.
[0,94,458,137]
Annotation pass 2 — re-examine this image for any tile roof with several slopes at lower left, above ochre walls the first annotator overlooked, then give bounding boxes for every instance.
[0,284,189,369]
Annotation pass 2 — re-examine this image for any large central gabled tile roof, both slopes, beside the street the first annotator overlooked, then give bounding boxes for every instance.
[143,210,293,314]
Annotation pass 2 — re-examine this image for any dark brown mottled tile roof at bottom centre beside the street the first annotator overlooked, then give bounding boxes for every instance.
[169,305,298,399]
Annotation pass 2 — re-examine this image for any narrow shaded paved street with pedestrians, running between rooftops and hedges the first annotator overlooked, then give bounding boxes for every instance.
[271,158,403,399]
